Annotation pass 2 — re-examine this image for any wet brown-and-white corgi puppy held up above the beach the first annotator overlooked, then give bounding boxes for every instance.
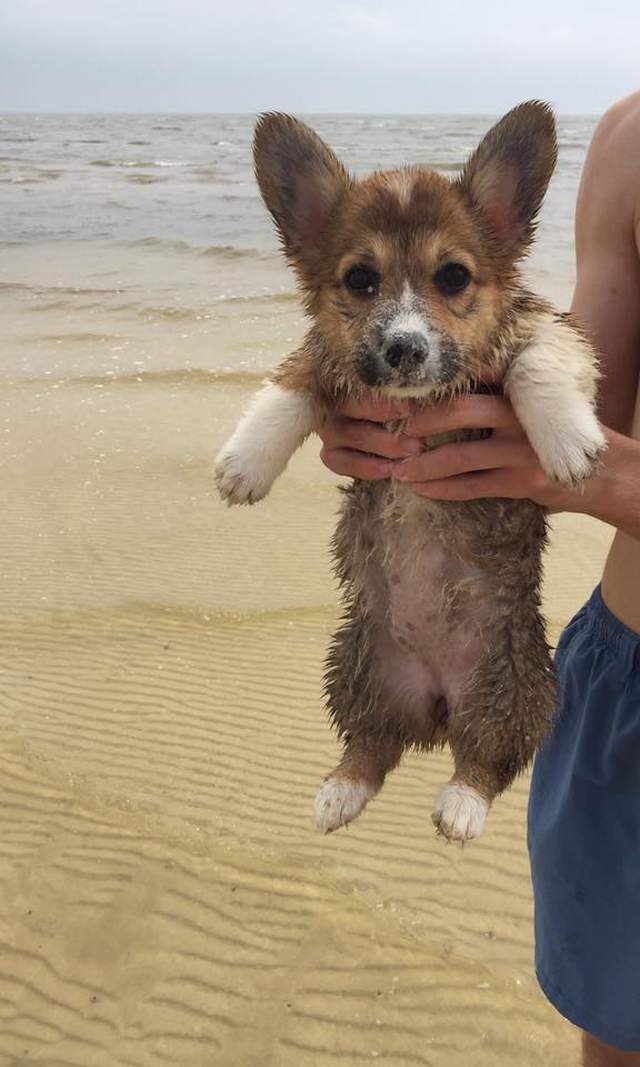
[217,101,605,841]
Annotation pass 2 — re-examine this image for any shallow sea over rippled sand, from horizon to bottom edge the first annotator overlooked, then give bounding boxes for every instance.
[0,115,609,1067]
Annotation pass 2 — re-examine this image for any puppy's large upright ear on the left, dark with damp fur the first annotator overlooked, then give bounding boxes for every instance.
[254,113,351,260]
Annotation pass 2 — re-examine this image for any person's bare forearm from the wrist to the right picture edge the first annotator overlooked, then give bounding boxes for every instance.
[554,430,640,541]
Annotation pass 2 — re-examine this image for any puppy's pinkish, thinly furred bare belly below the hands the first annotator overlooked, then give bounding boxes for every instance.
[369,485,491,721]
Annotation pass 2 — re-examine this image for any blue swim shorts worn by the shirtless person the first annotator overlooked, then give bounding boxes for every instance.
[528,588,640,1051]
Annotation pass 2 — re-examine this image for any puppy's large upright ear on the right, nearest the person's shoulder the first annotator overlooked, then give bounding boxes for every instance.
[459,100,558,258]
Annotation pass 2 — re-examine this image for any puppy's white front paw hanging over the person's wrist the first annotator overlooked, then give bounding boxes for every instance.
[531,407,607,489]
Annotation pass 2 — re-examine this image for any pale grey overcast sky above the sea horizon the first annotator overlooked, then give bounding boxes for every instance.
[0,0,640,114]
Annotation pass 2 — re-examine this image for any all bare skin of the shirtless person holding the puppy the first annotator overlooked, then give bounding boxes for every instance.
[320,93,640,1067]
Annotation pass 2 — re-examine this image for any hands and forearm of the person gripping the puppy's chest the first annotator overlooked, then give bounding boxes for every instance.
[321,396,640,539]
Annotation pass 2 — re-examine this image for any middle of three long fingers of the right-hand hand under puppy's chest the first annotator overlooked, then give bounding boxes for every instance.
[393,437,537,482]
